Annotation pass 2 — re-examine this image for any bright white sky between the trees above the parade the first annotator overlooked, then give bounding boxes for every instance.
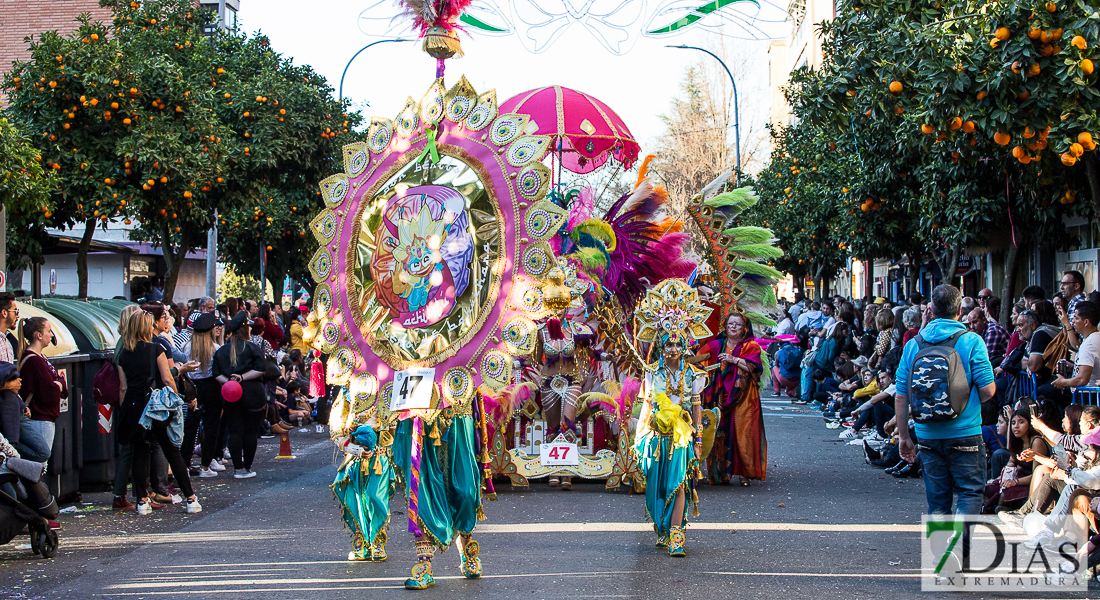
[238,0,770,153]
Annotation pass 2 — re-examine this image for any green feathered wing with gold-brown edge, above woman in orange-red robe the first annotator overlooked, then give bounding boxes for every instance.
[688,172,783,327]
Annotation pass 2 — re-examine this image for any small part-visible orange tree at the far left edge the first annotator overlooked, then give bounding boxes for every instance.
[0,118,55,270]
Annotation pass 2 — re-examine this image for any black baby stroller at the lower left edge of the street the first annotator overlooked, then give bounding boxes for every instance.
[0,458,59,558]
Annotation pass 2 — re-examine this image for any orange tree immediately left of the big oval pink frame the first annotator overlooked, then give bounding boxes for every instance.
[206,35,362,297]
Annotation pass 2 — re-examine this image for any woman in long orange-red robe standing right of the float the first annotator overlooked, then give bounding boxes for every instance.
[699,310,768,486]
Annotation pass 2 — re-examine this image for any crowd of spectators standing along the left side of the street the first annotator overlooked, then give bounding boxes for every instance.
[0,280,328,515]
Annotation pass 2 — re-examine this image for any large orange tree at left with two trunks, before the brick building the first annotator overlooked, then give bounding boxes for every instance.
[3,0,228,299]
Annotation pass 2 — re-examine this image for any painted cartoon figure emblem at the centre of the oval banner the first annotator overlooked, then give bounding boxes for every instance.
[374,185,473,328]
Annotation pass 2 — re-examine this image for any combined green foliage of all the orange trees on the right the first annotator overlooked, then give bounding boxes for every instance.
[758,0,1100,280]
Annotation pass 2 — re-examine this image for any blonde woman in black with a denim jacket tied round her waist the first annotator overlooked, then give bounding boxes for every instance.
[118,310,202,514]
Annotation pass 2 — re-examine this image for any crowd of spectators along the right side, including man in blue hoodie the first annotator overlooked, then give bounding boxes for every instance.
[769,271,1100,567]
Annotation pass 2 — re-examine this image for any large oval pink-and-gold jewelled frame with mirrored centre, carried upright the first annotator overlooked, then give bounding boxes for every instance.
[309,78,561,427]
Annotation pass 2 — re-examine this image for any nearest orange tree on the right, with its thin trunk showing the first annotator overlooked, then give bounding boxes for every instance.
[790,0,1096,306]
